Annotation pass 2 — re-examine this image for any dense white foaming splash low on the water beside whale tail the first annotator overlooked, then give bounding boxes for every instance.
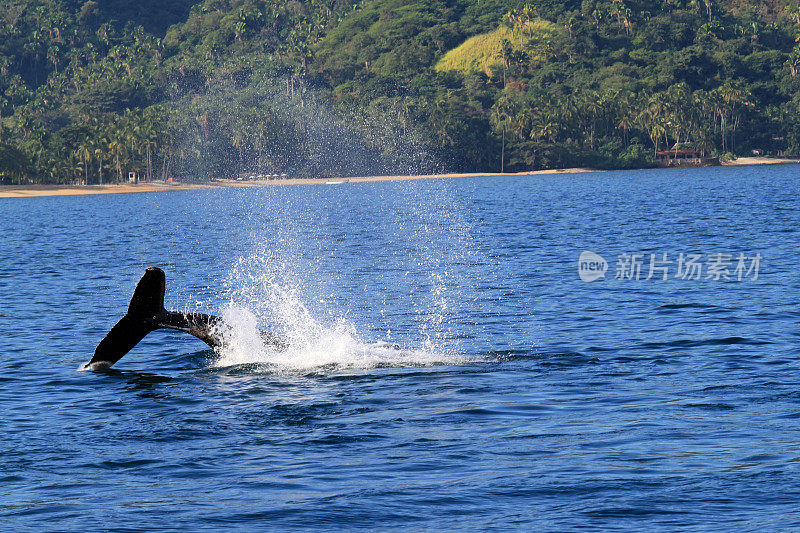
[205,243,464,372]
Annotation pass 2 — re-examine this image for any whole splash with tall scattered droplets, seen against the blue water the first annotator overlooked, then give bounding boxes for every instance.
[191,167,501,371]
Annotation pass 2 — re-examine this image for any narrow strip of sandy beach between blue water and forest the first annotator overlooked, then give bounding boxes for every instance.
[0,157,800,199]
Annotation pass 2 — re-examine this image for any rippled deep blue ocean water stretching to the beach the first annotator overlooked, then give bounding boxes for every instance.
[0,165,800,531]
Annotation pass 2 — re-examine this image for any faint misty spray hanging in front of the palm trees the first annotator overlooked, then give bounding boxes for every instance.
[172,70,446,179]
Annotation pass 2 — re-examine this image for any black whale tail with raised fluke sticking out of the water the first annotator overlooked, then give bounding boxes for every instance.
[82,267,287,370]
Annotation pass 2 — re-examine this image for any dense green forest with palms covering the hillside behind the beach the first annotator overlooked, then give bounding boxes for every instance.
[0,0,800,183]
